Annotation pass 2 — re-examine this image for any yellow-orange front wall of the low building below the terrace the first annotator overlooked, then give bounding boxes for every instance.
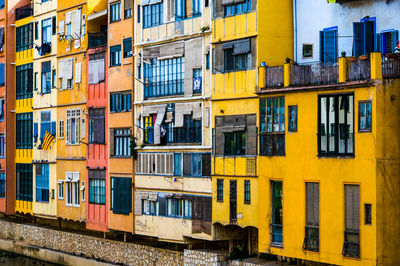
[258,87,378,265]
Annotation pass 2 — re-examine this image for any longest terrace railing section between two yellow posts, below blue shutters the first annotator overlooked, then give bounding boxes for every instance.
[290,63,339,86]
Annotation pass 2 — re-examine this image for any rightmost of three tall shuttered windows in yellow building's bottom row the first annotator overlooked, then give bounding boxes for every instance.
[342,185,360,258]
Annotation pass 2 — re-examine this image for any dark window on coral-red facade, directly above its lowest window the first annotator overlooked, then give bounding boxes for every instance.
[89,108,106,144]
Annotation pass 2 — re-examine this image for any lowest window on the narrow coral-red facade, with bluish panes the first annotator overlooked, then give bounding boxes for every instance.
[89,170,106,205]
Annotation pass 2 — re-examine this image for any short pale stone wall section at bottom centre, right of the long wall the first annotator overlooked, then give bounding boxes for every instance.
[183,249,228,266]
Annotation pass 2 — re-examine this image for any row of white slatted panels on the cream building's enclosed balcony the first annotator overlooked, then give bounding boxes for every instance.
[135,153,173,175]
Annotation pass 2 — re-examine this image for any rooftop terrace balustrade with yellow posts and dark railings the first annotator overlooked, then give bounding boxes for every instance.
[258,53,394,93]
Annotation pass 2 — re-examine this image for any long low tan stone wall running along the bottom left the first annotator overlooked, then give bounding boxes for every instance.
[0,220,184,265]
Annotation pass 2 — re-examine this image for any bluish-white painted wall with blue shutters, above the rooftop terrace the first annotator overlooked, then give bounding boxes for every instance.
[293,0,400,63]
